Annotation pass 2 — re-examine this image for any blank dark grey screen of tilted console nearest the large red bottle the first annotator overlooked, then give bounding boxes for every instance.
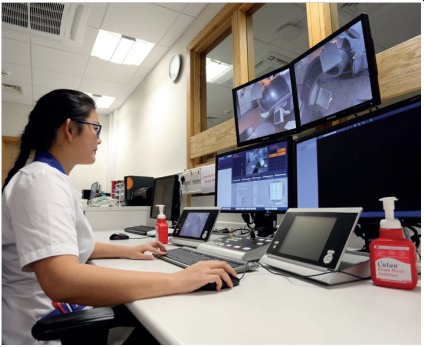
[279,215,337,261]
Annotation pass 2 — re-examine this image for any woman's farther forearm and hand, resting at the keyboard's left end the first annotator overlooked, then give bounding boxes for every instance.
[90,241,166,259]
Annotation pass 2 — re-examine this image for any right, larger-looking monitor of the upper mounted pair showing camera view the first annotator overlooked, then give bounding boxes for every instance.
[292,14,380,130]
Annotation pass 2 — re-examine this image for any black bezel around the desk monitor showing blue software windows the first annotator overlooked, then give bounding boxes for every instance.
[214,136,294,215]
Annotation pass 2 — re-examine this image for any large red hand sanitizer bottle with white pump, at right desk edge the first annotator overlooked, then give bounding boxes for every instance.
[370,197,418,289]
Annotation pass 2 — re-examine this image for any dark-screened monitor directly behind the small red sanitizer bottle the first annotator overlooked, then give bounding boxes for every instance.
[150,175,181,224]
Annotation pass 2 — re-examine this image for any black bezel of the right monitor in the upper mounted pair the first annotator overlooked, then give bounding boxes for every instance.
[291,13,381,132]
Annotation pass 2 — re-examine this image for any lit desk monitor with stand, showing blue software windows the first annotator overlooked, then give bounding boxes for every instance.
[215,137,292,236]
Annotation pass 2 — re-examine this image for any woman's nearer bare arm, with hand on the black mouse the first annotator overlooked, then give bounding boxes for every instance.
[32,255,237,306]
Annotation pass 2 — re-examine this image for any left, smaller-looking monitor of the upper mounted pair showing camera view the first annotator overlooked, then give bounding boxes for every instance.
[232,65,297,147]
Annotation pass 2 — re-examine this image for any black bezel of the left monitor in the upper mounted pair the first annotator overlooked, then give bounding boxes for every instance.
[232,64,299,147]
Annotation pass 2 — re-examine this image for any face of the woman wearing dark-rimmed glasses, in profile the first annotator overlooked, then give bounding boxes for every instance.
[75,109,102,164]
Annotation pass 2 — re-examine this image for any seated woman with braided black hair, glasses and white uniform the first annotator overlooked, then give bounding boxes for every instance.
[2,89,236,344]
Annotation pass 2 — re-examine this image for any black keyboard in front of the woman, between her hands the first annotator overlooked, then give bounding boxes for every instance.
[154,247,257,273]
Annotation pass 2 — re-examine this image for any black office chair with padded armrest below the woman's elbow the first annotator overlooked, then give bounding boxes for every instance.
[31,305,157,345]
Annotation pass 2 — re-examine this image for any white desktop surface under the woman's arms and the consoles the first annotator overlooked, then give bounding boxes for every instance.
[94,231,421,345]
